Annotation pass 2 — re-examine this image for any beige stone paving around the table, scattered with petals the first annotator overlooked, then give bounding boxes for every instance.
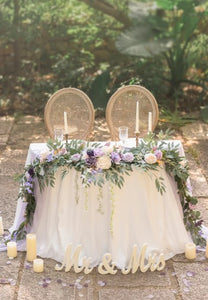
[0,116,208,300]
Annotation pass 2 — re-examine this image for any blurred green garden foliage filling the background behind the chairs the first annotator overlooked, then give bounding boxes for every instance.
[0,0,208,120]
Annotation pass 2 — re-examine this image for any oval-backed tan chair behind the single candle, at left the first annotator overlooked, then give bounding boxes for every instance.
[44,88,94,139]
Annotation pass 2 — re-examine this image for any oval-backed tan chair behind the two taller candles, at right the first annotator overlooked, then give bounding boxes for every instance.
[106,85,159,140]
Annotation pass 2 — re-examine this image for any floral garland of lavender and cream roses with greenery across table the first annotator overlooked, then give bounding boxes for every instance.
[12,132,205,245]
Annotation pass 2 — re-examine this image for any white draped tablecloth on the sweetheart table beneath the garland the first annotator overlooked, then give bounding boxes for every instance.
[10,140,191,268]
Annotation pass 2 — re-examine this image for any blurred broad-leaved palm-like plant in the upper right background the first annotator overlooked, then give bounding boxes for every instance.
[117,0,207,108]
